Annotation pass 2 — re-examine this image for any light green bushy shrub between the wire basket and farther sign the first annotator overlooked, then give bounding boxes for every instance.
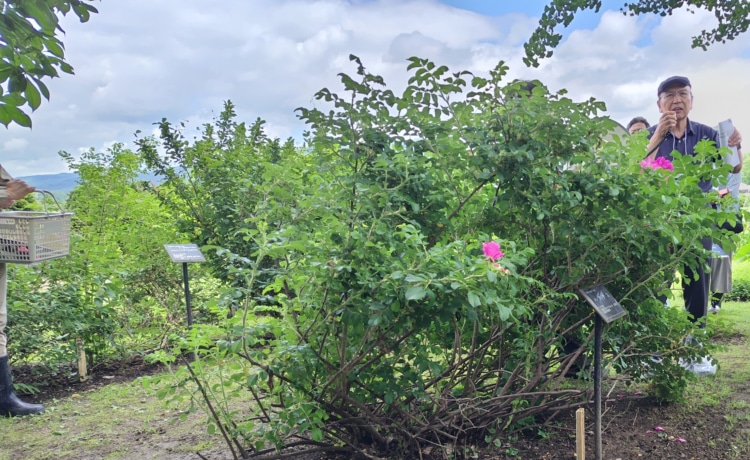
[8,144,184,367]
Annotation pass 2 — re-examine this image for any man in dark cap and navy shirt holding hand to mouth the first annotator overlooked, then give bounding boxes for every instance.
[648,76,742,321]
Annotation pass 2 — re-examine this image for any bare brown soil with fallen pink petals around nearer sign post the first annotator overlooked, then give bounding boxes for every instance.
[494,388,749,460]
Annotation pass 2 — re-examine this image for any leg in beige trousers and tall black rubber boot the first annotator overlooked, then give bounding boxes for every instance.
[0,263,44,417]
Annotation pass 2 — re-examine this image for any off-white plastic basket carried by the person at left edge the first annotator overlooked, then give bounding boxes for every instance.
[0,190,73,264]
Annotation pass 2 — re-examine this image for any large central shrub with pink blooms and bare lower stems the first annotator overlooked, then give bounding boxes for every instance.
[144,57,725,458]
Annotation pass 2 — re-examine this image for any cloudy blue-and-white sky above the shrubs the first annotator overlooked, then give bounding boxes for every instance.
[0,0,750,176]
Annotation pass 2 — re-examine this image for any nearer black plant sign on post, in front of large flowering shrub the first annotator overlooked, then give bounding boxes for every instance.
[580,284,627,460]
